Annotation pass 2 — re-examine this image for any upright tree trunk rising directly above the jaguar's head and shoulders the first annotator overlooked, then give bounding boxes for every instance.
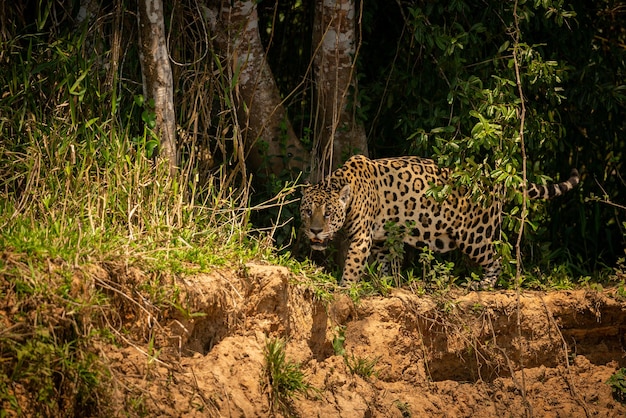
[313,0,368,179]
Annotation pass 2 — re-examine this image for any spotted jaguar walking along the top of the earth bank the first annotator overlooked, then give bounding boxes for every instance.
[300,155,580,289]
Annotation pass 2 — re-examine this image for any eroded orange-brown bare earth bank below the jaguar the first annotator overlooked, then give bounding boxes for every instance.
[101,265,626,417]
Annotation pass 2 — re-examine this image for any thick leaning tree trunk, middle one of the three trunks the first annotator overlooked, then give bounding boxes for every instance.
[207,0,310,175]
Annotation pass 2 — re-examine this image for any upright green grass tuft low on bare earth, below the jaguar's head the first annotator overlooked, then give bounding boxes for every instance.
[264,338,312,415]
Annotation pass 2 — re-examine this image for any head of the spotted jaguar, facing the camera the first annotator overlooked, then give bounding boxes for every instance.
[300,182,350,251]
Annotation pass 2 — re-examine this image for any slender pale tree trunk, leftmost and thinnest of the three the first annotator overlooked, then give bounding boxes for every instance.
[137,0,178,174]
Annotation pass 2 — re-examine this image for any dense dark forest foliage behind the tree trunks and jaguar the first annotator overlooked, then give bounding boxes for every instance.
[0,0,626,280]
